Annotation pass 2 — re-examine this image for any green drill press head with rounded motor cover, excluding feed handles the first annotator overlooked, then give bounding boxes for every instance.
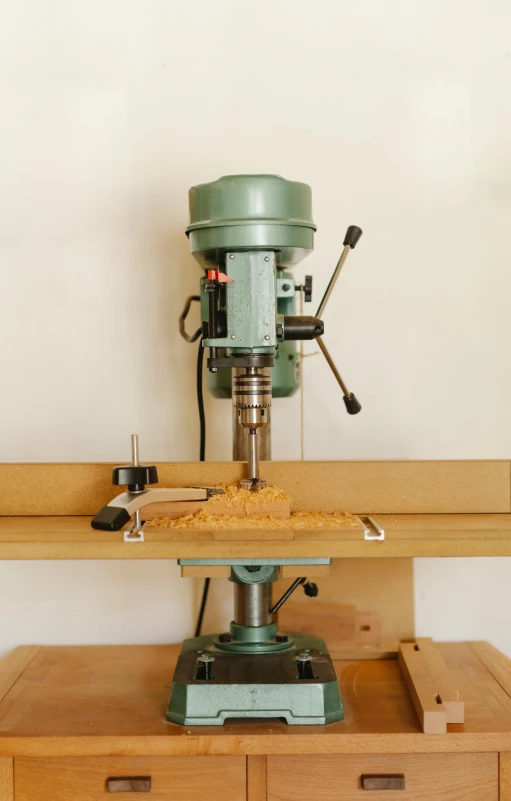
[186,175,322,410]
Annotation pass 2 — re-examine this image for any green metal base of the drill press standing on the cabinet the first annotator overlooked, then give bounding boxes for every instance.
[167,634,343,726]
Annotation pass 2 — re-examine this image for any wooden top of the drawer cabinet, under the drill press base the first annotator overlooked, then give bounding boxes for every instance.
[0,643,511,757]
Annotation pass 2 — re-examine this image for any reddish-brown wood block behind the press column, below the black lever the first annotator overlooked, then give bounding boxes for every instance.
[279,600,355,651]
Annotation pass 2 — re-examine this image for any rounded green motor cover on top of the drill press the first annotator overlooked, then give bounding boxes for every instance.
[186,175,316,267]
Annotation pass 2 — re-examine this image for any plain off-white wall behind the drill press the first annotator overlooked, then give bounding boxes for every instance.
[0,0,511,653]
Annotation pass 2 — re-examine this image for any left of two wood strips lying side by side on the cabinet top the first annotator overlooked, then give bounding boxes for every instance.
[399,643,447,734]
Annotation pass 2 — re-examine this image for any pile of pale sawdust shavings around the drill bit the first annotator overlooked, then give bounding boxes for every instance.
[146,484,358,530]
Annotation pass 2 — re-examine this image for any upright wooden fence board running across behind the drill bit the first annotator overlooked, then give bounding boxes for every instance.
[0,461,511,515]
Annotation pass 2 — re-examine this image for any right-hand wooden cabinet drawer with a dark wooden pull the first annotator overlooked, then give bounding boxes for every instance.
[268,754,498,801]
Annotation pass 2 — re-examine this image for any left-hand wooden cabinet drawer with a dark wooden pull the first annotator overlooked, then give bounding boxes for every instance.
[14,756,246,801]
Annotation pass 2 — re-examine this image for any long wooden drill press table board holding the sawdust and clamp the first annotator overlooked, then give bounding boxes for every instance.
[0,514,511,559]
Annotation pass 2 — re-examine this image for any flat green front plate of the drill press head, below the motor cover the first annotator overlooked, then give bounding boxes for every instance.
[204,250,277,353]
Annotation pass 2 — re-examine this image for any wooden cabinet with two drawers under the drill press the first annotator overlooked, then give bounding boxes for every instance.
[0,643,511,801]
